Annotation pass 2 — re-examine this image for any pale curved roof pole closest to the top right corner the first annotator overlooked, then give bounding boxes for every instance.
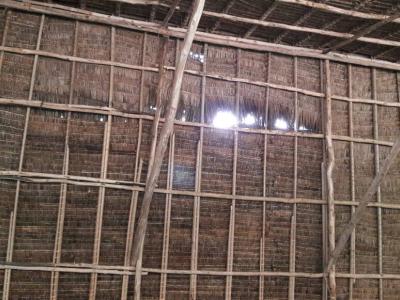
[277,0,400,23]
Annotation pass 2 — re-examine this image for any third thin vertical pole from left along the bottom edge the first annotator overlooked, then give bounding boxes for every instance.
[89,26,115,300]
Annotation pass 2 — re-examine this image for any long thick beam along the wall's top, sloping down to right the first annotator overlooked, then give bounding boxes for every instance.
[0,0,400,70]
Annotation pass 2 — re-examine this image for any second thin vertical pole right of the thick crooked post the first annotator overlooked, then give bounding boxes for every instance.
[372,68,383,300]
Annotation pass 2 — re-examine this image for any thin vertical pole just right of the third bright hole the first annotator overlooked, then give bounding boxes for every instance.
[289,57,299,300]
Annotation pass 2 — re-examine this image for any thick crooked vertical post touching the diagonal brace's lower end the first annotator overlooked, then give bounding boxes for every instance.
[325,60,336,300]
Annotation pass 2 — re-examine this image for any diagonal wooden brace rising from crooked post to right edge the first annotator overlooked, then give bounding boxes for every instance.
[324,137,400,274]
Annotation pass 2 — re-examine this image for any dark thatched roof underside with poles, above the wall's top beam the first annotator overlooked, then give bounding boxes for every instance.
[39,0,400,62]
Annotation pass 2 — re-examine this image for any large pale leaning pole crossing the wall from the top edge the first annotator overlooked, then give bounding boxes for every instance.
[132,0,205,265]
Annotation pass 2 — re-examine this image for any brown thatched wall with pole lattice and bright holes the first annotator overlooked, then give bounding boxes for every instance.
[0,7,400,299]
